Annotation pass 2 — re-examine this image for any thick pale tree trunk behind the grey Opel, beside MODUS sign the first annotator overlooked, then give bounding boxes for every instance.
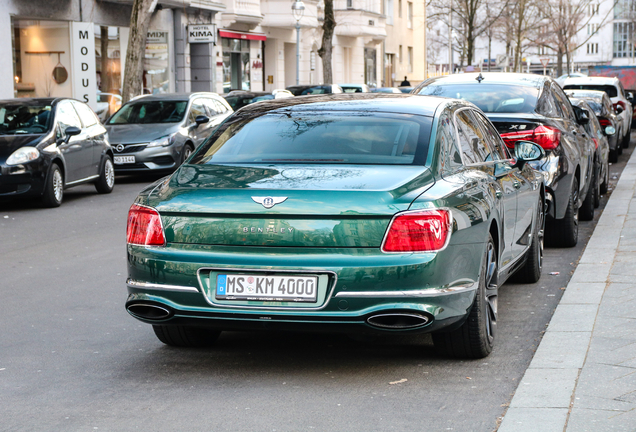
[121,0,154,103]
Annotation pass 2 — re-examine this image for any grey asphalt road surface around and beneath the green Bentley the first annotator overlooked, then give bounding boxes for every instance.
[0,143,631,432]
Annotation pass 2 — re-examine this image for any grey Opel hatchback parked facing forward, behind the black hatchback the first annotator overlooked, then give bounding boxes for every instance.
[106,92,233,173]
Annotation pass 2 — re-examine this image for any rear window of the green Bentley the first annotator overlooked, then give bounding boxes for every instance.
[190,112,432,165]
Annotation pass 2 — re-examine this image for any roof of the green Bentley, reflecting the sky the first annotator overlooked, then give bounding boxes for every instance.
[234,93,452,117]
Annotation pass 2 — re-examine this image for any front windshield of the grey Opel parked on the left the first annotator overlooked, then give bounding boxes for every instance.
[108,101,188,125]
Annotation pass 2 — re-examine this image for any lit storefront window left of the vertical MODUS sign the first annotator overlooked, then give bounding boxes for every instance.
[11,18,72,97]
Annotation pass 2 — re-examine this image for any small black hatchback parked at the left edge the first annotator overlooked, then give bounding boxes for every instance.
[0,98,115,207]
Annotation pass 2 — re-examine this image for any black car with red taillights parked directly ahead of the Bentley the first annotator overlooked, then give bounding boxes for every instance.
[413,73,594,247]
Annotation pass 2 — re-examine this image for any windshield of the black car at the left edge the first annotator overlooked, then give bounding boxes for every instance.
[0,103,51,135]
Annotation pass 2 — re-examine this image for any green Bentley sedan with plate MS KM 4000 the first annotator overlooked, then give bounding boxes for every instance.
[126,94,545,358]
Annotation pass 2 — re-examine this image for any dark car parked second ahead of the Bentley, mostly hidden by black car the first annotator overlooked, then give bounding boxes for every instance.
[570,98,615,213]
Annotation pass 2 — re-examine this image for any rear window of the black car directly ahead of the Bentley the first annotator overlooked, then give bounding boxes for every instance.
[419,82,539,113]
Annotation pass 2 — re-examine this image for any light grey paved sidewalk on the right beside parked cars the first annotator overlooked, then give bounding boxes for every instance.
[498,152,636,432]
